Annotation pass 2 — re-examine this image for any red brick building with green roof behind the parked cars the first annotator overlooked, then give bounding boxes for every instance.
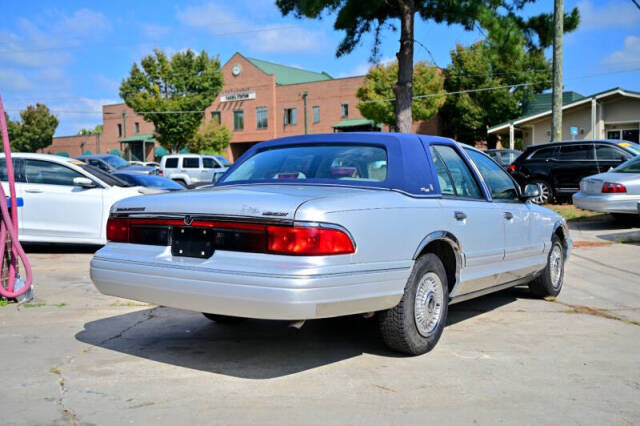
[46,53,439,161]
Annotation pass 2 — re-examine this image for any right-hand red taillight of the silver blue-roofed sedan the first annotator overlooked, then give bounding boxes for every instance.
[267,226,355,256]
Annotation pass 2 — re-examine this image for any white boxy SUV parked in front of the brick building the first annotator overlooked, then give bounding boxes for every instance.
[160,154,229,188]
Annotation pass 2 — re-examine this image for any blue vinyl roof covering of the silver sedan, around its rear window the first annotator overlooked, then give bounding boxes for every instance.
[217,132,464,196]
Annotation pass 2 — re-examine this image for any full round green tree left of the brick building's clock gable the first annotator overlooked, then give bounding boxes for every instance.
[120,49,223,152]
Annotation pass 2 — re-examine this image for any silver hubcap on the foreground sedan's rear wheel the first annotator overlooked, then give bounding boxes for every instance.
[414,272,444,337]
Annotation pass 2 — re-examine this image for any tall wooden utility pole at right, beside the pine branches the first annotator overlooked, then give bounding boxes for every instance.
[551,0,564,142]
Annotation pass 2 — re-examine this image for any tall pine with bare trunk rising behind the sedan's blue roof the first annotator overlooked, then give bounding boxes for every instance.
[276,0,578,132]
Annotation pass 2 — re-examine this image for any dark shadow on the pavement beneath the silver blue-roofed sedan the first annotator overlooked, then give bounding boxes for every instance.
[76,292,516,379]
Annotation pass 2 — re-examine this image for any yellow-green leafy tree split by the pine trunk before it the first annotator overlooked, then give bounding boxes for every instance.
[356,61,445,128]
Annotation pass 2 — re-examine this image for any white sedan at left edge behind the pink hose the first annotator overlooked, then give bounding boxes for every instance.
[0,153,148,244]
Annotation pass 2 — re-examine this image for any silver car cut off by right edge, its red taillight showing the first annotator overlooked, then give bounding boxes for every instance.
[573,156,640,219]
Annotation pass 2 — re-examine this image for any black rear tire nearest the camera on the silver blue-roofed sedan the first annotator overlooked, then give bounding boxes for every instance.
[378,253,449,355]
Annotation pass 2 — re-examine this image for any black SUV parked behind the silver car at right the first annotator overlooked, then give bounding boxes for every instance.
[509,140,640,204]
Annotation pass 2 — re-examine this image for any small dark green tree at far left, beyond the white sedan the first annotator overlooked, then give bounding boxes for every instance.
[7,103,59,152]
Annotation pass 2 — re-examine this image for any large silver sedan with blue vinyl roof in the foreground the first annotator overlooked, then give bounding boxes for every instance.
[91,132,572,354]
